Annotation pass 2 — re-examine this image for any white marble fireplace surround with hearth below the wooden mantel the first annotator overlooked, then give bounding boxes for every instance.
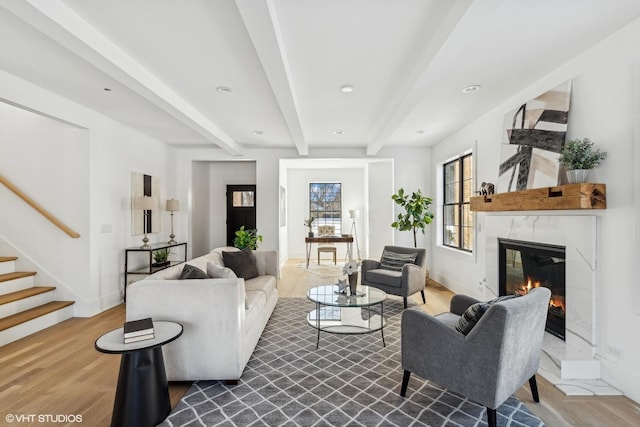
[485,214,621,395]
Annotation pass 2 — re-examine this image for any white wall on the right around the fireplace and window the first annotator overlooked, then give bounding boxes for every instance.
[432,16,640,401]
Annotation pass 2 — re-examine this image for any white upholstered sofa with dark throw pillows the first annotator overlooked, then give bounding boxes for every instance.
[126,248,278,381]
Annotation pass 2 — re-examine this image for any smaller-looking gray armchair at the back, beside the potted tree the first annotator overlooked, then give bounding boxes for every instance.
[361,246,427,308]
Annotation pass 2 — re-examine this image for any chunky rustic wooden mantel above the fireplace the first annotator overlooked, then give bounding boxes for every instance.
[470,183,607,212]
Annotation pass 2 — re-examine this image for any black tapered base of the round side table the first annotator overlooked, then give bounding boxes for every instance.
[111,346,171,427]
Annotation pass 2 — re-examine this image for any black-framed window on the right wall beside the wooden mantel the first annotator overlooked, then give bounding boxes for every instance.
[442,154,473,252]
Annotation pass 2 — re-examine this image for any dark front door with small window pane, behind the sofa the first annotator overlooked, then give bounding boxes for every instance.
[227,185,256,246]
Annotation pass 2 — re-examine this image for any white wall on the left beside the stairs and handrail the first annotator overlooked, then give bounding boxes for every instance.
[0,71,178,316]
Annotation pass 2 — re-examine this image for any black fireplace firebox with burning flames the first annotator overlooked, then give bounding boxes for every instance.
[498,238,566,340]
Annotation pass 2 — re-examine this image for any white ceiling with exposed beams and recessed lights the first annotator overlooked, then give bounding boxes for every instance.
[0,0,640,155]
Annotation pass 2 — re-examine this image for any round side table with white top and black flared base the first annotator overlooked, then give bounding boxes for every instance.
[95,321,183,427]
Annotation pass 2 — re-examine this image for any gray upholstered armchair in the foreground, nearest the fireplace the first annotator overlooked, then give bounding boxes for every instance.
[400,287,551,427]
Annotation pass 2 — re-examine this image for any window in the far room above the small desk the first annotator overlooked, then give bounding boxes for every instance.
[309,182,342,235]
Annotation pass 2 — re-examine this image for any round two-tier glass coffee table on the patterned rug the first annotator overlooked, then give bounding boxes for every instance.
[307,285,387,348]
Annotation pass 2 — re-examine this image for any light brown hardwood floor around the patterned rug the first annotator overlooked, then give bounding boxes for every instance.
[0,260,640,427]
